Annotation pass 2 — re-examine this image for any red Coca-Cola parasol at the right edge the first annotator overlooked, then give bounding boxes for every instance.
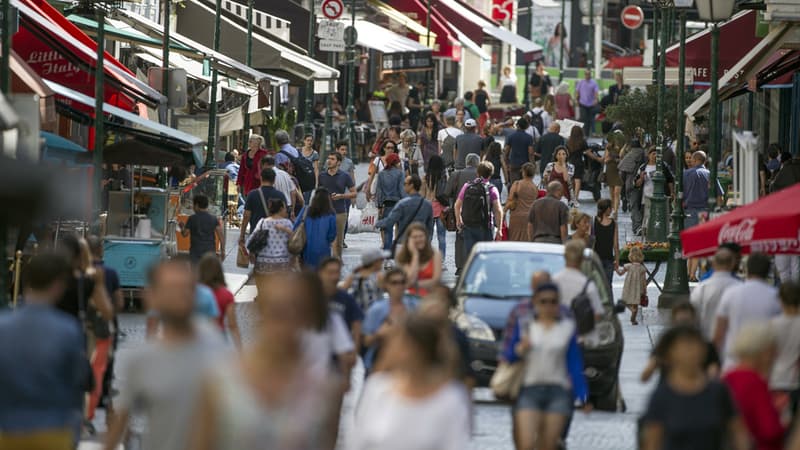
[681,184,800,258]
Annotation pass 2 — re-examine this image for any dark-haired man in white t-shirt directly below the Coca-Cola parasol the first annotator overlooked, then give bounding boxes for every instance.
[714,253,781,370]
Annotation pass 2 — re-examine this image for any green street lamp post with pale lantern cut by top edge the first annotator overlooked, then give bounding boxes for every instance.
[696,0,735,211]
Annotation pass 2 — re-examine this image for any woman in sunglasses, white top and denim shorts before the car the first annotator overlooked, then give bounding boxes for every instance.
[503,283,588,450]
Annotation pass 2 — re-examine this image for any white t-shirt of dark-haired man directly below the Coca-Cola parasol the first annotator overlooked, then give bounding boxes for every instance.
[717,279,781,370]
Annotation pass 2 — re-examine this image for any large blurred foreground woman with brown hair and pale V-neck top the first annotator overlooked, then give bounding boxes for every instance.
[189,272,342,450]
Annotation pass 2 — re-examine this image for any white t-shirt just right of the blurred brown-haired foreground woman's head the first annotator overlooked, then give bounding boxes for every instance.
[303,312,355,375]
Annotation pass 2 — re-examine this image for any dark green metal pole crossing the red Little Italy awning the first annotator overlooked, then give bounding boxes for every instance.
[92,5,106,213]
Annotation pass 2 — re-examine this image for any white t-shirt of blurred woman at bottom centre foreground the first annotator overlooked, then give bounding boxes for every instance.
[350,373,471,450]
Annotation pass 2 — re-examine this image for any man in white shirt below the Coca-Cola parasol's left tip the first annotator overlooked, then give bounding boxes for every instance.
[691,247,741,339]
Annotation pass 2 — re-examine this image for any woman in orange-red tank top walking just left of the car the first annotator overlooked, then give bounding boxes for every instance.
[397,222,442,297]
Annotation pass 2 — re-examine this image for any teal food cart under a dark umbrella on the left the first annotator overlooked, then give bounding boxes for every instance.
[103,135,202,292]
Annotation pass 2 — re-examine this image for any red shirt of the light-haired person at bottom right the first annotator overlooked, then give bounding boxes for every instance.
[722,367,786,450]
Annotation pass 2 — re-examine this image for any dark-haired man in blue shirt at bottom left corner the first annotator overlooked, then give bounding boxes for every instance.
[0,254,92,448]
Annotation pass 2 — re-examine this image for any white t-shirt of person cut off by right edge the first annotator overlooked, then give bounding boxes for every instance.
[769,314,800,391]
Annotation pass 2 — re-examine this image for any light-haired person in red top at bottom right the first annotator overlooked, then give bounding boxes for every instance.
[722,323,787,450]
